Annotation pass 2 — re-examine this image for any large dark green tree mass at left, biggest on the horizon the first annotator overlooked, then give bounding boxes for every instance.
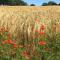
[0,0,27,5]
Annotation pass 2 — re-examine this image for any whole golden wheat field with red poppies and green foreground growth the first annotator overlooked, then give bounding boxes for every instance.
[0,6,60,60]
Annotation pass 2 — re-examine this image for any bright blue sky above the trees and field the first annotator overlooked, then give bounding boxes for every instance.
[23,0,60,6]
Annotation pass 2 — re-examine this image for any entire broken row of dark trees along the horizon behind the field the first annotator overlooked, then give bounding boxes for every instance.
[0,0,60,6]
